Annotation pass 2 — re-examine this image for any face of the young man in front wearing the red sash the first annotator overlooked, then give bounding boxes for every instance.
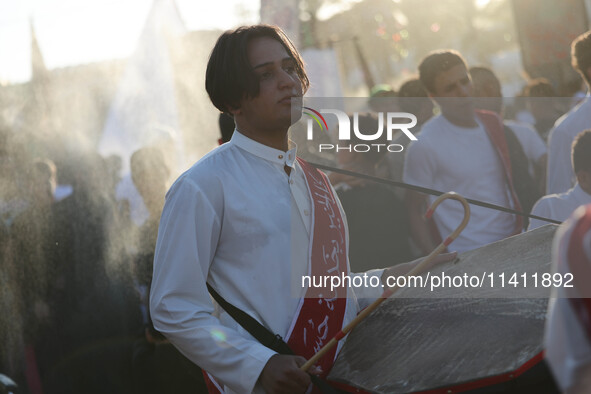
[233,37,302,133]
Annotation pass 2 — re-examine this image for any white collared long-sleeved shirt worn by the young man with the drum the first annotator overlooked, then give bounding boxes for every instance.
[150,131,389,393]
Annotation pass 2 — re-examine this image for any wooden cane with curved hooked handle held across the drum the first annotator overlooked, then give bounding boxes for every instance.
[300,192,470,371]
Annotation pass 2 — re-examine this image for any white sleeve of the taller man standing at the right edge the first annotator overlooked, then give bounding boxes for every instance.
[546,126,574,194]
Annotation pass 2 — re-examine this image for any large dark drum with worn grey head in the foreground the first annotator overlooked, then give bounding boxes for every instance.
[329,225,557,393]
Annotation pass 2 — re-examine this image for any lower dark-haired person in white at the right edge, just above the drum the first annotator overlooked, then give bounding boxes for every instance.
[528,130,591,230]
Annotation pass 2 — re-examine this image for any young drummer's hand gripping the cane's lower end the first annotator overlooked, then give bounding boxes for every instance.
[260,354,320,394]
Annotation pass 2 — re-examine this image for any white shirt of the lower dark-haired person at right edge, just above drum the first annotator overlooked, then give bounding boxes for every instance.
[527,183,591,230]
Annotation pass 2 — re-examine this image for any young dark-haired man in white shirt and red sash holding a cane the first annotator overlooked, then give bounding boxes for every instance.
[150,25,454,393]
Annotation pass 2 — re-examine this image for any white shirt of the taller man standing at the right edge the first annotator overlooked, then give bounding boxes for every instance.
[546,96,591,194]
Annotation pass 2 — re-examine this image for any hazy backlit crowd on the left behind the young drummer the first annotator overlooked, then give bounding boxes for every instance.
[0,127,208,393]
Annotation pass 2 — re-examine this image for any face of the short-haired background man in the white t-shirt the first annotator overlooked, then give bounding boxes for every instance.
[430,64,474,118]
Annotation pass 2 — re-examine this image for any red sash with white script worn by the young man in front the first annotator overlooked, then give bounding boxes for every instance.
[203,157,349,394]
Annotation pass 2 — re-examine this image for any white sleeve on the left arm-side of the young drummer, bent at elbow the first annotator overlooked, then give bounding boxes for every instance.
[150,177,275,393]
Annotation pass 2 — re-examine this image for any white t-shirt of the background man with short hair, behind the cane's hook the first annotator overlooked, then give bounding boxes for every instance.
[404,115,516,252]
